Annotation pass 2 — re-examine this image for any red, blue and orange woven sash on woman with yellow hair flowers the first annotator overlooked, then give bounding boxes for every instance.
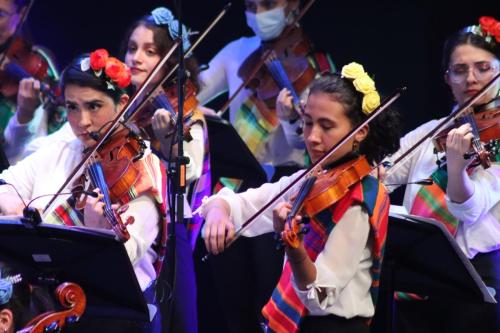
[262,176,389,333]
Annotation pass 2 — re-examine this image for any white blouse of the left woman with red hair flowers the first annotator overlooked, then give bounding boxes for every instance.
[0,136,160,290]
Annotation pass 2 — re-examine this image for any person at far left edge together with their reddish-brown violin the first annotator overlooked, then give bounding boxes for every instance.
[0,0,66,164]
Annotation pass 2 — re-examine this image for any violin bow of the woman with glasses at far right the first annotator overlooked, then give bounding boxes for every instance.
[380,73,500,178]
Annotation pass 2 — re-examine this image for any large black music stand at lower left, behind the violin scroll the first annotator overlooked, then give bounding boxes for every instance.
[0,218,149,324]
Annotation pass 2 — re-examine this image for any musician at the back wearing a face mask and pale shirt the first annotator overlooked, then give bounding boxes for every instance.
[198,0,335,179]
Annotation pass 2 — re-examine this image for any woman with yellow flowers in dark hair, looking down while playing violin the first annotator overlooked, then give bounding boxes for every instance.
[202,63,399,332]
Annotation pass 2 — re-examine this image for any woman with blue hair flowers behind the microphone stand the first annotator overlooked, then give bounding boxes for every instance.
[124,7,211,244]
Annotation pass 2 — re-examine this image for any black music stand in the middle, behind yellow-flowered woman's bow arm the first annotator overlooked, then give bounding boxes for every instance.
[205,115,267,190]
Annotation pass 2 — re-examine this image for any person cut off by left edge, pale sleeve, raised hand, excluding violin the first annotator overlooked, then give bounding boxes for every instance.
[0,0,66,164]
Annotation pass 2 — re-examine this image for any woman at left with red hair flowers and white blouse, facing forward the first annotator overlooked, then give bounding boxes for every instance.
[0,52,166,331]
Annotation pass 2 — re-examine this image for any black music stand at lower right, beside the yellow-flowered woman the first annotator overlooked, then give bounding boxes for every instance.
[372,213,496,332]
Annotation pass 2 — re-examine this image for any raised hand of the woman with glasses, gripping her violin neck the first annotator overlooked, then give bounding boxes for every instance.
[446,123,474,171]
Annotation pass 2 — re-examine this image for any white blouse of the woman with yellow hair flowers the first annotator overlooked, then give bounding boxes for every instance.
[201,171,374,318]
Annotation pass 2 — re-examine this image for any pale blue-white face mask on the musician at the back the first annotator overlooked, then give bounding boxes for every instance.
[245,7,287,41]
